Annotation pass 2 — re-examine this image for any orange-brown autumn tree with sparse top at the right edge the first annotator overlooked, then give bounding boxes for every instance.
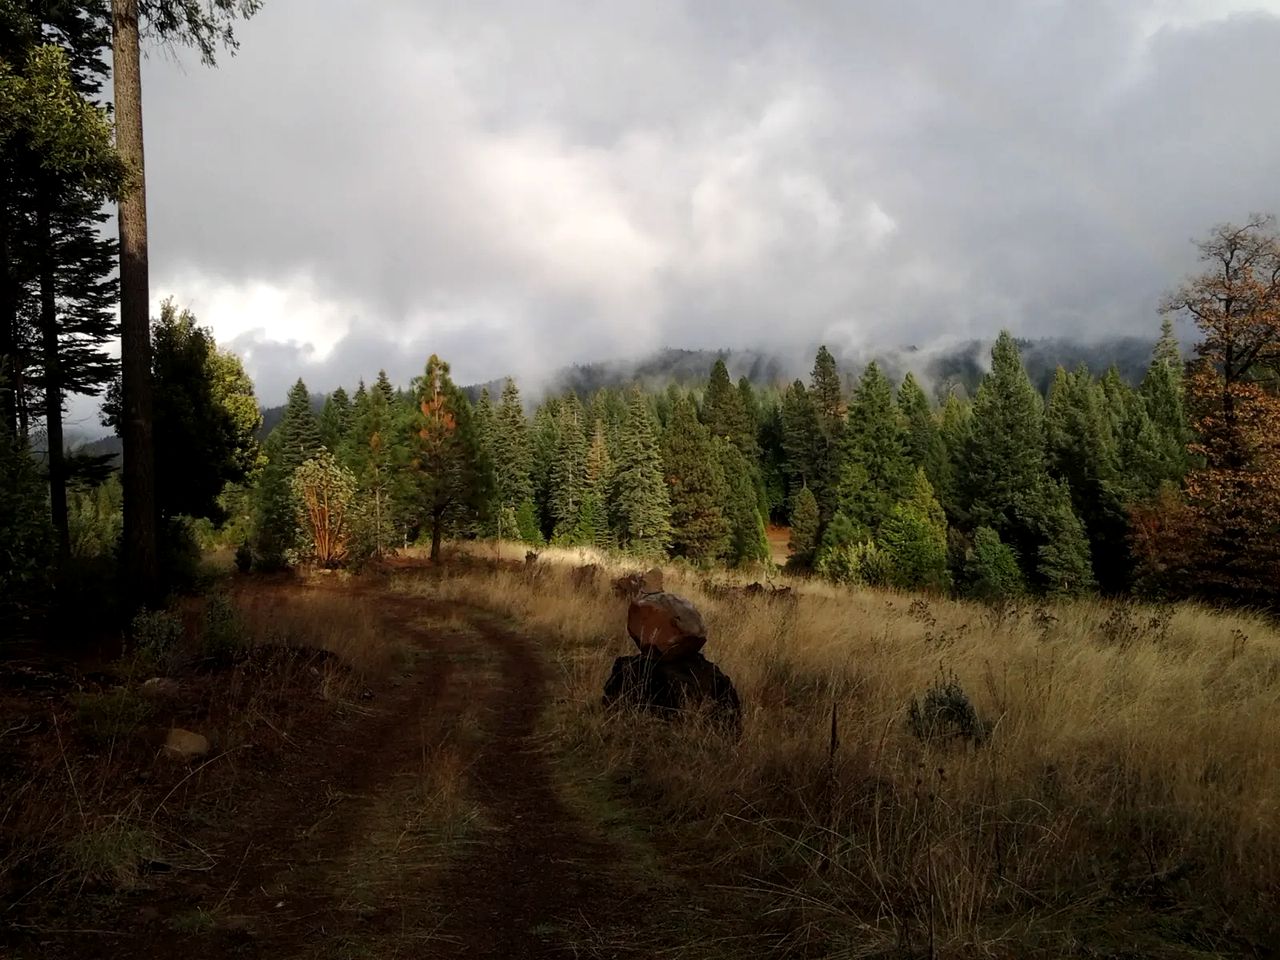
[1164,216,1280,603]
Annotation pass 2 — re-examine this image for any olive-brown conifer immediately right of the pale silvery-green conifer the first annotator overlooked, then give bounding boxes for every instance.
[663,398,730,562]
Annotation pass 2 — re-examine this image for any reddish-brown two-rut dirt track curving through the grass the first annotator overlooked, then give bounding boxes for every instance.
[135,595,645,960]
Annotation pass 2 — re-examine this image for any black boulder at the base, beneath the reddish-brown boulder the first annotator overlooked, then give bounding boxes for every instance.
[603,653,742,735]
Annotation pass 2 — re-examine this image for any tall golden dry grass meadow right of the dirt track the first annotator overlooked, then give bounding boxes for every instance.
[404,548,1280,956]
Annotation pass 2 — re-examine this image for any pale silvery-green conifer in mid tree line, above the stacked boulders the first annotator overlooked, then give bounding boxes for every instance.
[613,389,671,556]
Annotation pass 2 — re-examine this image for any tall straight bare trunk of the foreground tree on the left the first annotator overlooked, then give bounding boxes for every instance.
[111,0,159,603]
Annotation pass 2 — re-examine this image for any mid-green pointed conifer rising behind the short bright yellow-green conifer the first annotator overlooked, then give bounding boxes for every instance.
[837,361,914,535]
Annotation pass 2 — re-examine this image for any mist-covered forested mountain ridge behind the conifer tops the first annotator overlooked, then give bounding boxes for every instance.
[79,337,1155,456]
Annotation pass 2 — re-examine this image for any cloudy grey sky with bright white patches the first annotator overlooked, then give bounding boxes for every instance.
[82,0,1280,419]
